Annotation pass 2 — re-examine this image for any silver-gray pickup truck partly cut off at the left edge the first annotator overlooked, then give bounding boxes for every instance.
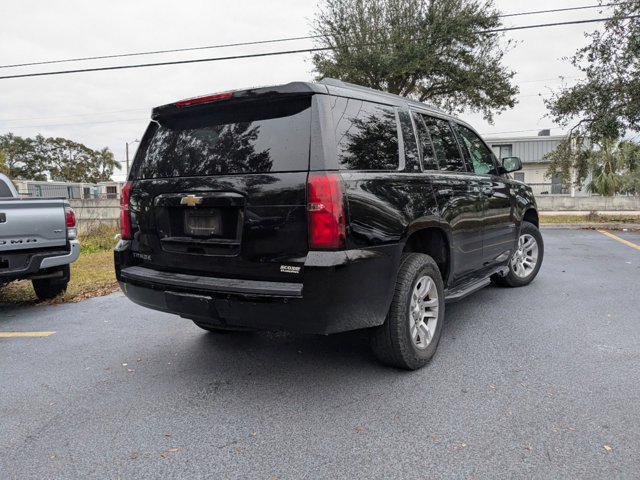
[0,174,80,300]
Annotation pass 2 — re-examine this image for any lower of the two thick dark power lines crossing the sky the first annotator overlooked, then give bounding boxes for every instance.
[0,15,640,80]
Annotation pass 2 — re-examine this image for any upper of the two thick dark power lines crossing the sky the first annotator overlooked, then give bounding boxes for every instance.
[0,2,630,68]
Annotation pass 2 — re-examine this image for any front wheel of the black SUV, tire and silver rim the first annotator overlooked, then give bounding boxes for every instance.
[491,222,544,287]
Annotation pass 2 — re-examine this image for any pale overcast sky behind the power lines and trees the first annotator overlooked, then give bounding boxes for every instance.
[0,0,599,179]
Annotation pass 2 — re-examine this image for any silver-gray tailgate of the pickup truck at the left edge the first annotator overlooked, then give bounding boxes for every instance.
[0,198,67,253]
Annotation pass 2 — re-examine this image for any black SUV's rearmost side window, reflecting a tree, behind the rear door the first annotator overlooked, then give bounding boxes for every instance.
[332,97,399,170]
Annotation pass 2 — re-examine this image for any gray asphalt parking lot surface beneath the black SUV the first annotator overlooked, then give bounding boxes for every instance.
[0,229,640,479]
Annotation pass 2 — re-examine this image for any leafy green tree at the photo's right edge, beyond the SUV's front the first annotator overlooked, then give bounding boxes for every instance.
[546,1,640,194]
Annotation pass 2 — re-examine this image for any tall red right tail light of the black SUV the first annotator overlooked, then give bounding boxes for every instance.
[307,173,346,250]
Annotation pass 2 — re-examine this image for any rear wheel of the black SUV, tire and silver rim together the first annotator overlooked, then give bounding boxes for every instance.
[369,253,444,370]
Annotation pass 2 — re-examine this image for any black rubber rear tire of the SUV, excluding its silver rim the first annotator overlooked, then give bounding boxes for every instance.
[369,253,444,370]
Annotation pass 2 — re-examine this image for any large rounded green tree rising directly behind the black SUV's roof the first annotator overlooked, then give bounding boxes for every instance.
[313,0,518,121]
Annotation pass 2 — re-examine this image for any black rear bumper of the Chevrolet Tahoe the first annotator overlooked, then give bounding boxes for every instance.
[115,244,399,334]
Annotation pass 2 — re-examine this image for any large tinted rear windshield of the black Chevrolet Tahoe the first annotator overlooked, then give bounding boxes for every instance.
[132,97,311,179]
